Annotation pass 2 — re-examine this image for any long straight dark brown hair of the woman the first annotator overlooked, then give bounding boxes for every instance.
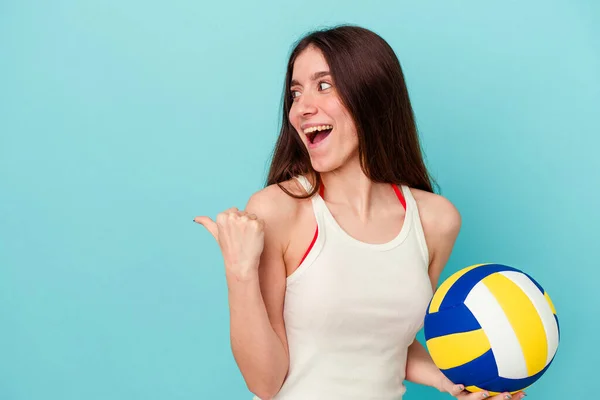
[266,25,435,198]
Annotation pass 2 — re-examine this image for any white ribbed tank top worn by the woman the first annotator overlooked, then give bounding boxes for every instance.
[254,176,433,400]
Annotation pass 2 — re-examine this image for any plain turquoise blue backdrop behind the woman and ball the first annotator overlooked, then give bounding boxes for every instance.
[0,0,600,400]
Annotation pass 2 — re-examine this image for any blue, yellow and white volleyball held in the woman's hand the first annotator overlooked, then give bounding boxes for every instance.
[423,264,560,395]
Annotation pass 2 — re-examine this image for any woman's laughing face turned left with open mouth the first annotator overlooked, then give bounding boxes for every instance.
[289,46,358,172]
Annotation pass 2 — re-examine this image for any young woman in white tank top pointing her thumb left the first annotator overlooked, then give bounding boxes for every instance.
[195,26,524,400]
